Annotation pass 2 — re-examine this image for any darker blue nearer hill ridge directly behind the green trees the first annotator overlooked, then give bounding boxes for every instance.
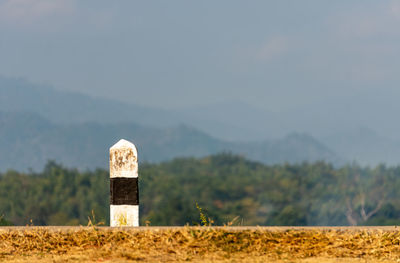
[0,112,339,171]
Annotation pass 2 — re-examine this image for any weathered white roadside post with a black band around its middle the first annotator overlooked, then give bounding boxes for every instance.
[110,140,139,227]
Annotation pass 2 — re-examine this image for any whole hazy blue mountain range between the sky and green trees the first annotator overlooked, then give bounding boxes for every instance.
[0,77,400,170]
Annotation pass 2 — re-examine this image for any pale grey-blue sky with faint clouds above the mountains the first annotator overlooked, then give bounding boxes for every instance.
[0,0,400,111]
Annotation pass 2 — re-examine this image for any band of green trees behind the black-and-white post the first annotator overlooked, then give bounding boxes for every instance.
[0,154,400,226]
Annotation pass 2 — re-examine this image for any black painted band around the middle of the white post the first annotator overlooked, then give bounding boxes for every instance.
[110,177,139,205]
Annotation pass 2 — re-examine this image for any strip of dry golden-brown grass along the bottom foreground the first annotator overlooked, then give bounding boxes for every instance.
[0,227,400,263]
